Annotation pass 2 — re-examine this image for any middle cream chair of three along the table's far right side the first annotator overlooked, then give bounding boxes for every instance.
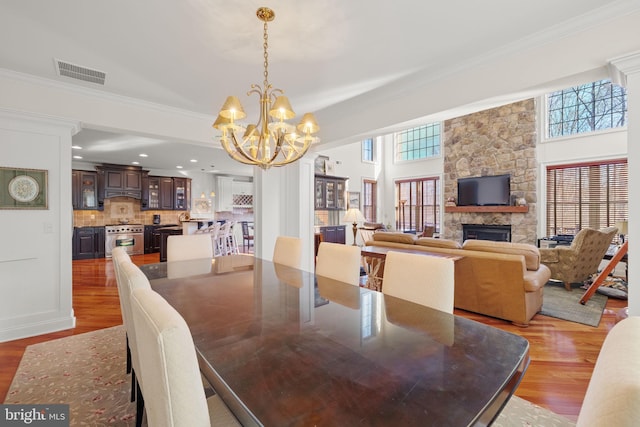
[316,242,360,286]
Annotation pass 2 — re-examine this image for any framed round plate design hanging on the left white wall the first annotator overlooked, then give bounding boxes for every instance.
[0,166,49,209]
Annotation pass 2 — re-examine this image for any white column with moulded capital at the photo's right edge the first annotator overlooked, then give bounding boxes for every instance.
[610,52,640,316]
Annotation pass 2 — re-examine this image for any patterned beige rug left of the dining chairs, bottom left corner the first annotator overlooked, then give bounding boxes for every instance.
[4,326,136,427]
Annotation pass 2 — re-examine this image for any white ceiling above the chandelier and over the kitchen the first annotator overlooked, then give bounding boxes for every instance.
[0,0,640,173]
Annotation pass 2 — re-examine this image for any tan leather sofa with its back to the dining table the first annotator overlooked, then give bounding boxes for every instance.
[366,232,551,326]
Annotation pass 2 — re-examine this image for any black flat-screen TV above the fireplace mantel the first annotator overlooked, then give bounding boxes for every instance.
[458,175,511,206]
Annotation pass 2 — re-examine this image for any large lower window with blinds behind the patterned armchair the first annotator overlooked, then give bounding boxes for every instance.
[547,159,629,236]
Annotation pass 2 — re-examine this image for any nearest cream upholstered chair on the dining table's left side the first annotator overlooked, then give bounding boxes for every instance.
[131,289,240,427]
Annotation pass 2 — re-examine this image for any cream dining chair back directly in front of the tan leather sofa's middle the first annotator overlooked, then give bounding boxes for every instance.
[382,251,454,313]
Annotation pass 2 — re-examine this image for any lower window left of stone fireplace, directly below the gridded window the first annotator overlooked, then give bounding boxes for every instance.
[396,177,440,233]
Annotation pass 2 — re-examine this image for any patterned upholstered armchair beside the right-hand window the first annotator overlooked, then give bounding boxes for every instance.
[540,227,618,291]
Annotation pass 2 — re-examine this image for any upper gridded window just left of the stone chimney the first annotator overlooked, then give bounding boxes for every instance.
[395,123,440,161]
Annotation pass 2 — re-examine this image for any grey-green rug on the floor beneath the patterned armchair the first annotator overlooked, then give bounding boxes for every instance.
[539,282,607,328]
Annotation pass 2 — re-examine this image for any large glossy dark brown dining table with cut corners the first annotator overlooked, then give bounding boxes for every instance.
[140,254,530,426]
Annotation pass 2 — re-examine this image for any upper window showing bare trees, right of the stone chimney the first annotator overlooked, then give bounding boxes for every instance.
[547,80,627,138]
